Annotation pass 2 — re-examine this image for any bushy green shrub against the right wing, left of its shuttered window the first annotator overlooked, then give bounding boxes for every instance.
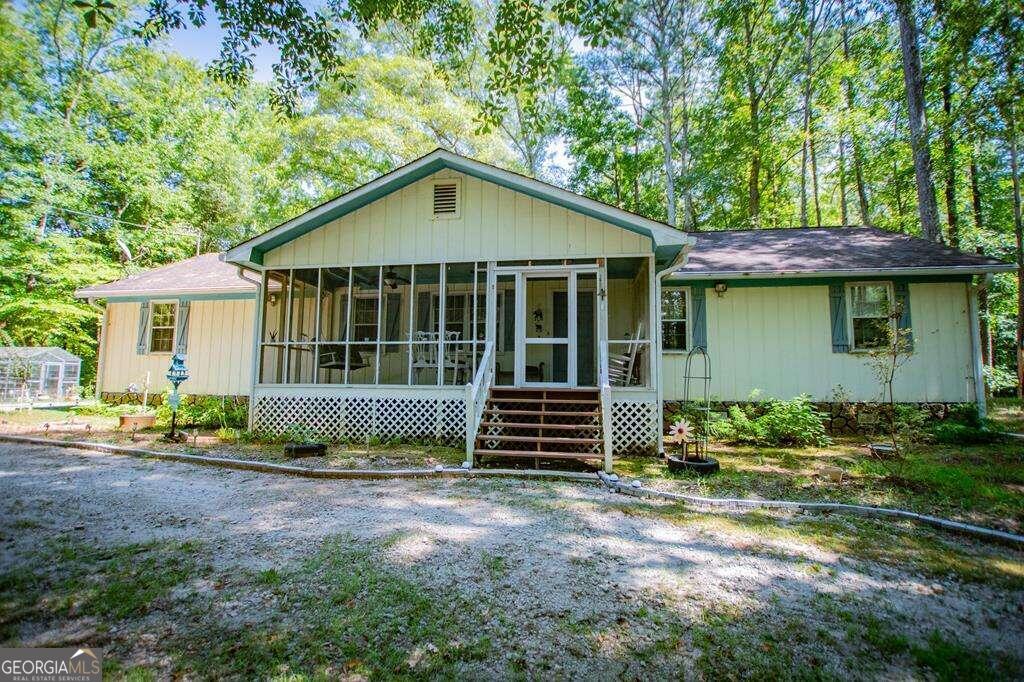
[716,395,829,446]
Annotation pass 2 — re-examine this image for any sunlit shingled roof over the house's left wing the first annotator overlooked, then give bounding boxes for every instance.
[75,253,257,298]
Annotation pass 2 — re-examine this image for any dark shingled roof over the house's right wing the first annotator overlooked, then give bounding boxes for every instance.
[671,227,1016,280]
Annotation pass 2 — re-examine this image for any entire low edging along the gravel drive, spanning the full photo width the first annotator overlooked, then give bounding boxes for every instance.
[0,434,1024,547]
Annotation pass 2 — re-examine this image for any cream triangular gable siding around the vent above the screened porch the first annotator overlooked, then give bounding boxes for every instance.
[263,170,651,267]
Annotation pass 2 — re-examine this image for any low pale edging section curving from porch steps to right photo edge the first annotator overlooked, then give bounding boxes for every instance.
[598,472,1024,547]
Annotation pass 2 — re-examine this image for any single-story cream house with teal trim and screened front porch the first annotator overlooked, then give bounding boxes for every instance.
[78,150,1013,462]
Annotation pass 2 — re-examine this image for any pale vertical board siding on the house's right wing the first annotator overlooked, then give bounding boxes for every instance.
[663,283,975,402]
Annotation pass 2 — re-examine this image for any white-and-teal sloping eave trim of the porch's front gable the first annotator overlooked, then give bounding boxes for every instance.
[225,148,693,267]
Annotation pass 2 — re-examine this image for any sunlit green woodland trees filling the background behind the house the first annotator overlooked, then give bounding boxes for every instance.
[0,0,1024,393]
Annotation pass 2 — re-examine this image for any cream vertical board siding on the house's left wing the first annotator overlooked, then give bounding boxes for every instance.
[99,298,256,395]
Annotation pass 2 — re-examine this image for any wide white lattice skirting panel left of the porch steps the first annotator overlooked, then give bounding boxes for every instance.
[253,395,466,444]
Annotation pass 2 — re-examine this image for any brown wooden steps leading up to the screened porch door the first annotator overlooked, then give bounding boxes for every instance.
[474,386,604,468]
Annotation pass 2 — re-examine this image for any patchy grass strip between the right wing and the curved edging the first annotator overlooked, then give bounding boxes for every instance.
[616,438,1024,532]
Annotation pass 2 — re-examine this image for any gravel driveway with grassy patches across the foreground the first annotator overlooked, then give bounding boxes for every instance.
[0,443,1024,679]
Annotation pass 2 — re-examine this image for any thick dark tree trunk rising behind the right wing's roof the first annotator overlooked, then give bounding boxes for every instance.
[896,0,939,242]
